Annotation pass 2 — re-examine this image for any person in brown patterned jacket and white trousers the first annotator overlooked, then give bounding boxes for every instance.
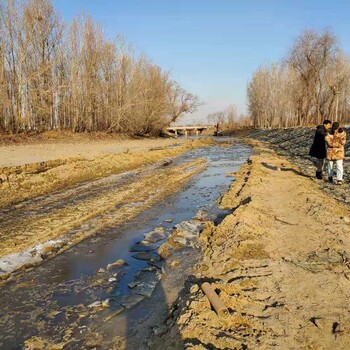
[326,122,346,185]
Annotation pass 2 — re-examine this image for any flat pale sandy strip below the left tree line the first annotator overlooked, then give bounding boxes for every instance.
[0,138,185,168]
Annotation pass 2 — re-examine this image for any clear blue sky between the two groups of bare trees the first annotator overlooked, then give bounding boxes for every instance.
[53,0,350,122]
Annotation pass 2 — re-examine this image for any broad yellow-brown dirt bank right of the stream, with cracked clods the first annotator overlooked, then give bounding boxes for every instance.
[152,142,350,350]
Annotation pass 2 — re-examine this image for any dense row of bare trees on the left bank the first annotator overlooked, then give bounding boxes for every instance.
[0,0,198,135]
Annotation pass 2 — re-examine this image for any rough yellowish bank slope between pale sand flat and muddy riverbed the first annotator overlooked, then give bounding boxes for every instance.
[0,139,211,208]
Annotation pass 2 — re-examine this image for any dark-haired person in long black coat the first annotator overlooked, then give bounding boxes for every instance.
[309,119,332,180]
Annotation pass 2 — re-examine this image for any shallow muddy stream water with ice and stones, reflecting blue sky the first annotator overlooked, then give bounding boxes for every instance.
[0,139,251,349]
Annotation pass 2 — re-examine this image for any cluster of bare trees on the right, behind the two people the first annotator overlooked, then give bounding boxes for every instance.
[247,31,350,128]
